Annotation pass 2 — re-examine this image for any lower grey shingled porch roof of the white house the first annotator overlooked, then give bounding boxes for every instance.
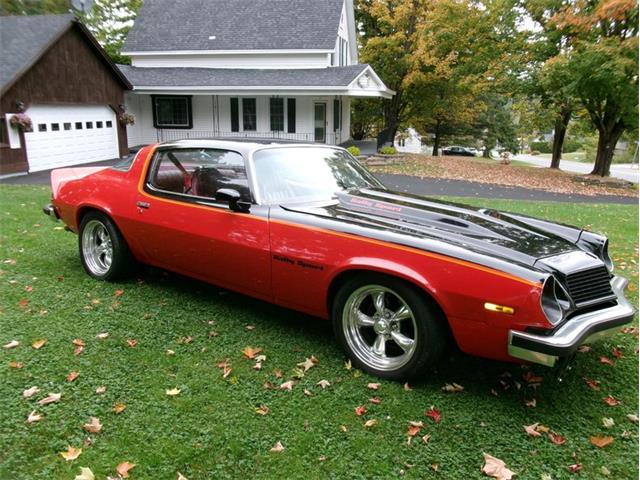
[118,64,368,88]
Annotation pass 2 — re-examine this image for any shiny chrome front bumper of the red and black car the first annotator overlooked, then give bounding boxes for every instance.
[509,277,635,367]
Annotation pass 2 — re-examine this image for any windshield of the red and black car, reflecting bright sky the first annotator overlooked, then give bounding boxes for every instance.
[253,147,384,204]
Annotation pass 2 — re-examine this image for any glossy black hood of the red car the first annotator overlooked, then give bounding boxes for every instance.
[282,190,581,270]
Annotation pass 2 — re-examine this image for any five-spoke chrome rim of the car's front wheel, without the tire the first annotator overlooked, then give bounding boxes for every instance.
[342,285,418,371]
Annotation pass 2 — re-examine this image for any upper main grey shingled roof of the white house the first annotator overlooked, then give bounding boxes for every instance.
[122,0,344,52]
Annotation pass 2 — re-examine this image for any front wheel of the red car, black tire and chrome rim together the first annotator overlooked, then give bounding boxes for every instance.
[332,273,446,380]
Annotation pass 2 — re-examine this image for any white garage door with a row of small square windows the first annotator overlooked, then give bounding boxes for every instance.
[25,105,119,172]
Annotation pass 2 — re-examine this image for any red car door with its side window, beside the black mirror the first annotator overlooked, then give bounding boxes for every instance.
[129,148,271,299]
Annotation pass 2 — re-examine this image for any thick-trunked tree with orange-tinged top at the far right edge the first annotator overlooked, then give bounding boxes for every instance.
[552,0,638,177]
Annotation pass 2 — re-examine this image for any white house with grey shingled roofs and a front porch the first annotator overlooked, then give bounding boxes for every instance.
[120,0,394,146]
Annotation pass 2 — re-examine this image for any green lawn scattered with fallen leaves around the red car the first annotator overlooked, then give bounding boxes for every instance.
[0,186,638,480]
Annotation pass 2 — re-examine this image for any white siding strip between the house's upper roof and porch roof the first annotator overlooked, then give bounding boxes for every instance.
[131,53,330,69]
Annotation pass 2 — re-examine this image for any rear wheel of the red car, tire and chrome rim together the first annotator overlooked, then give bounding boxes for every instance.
[78,211,133,281]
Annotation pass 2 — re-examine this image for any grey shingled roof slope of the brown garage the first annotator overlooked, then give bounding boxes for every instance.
[0,14,74,90]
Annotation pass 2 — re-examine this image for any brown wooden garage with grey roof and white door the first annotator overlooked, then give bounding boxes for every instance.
[0,14,131,177]
